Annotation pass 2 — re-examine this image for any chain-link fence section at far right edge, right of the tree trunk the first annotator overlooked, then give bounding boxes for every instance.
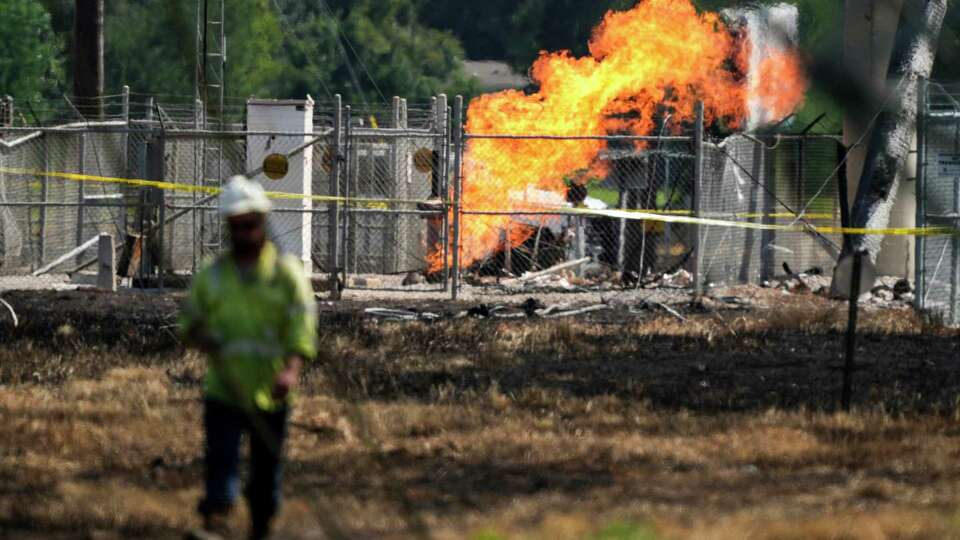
[916,82,960,324]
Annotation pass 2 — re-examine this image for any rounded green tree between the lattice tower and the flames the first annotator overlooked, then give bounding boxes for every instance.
[272,0,476,103]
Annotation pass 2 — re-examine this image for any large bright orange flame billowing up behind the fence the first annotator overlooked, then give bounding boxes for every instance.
[430,0,806,270]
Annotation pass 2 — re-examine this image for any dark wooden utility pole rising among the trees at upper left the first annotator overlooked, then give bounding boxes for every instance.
[73,0,103,119]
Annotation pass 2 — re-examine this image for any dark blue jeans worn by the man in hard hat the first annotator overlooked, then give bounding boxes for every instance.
[198,399,287,530]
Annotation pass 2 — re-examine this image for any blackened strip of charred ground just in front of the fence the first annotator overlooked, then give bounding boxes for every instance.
[0,281,948,411]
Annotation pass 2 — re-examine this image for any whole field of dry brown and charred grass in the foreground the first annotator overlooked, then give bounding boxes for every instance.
[0,291,960,539]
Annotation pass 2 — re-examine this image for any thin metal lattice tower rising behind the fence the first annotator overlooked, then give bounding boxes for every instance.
[194,0,227,256]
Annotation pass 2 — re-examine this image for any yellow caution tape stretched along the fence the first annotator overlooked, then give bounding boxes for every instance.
[0,167,960,236]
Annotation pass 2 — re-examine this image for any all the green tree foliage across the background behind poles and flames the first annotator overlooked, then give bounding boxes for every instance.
[0,0,960,122]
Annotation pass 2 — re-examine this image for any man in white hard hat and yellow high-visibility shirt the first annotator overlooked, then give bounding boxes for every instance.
[180,176,317,539]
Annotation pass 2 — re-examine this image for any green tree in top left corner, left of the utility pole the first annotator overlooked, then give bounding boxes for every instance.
[0,0,64,100]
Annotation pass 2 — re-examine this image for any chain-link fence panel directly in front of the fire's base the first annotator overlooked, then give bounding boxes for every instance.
[460,134,695,285]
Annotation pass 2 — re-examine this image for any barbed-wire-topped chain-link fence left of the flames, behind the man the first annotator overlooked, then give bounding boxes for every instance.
[0,98,451,289]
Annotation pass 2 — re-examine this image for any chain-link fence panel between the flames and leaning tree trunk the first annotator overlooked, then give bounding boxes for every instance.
[699,135,843,287]
